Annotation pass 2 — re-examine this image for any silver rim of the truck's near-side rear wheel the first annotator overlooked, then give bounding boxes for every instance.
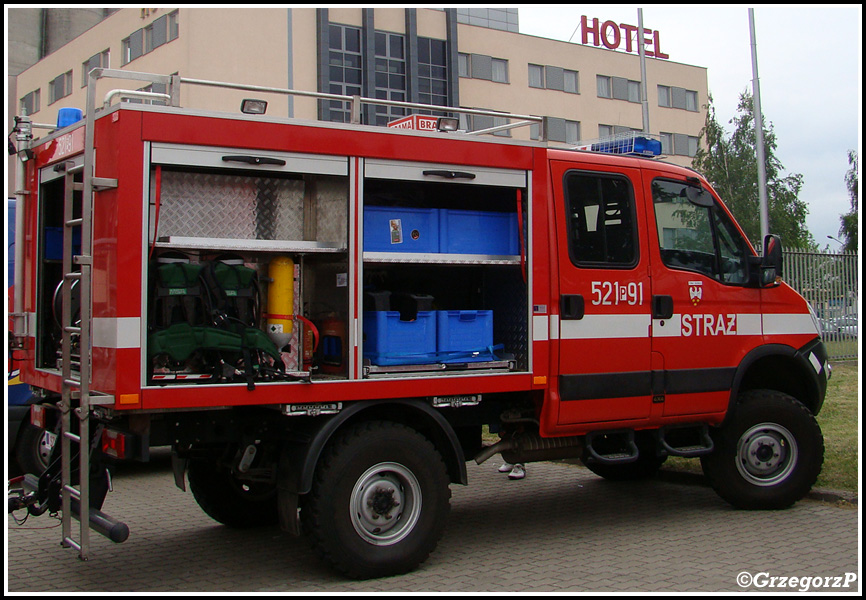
[350,462,421,546]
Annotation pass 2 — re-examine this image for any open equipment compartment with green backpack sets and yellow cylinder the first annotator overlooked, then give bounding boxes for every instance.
[144,144,349,388]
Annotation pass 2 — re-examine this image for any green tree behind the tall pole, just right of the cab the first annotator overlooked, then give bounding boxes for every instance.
[692,92,817,250]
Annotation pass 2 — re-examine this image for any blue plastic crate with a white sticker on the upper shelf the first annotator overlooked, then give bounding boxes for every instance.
[364,206,439,253]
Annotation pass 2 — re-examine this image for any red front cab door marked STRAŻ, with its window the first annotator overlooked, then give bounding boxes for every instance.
[643,169,762,417]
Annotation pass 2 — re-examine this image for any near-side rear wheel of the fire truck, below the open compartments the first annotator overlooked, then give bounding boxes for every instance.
[301,421,451,578]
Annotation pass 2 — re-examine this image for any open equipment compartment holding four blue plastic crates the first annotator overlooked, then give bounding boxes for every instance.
[362,160,529,377]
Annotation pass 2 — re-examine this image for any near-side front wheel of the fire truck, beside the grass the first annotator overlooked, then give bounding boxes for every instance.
[701,390,824,509]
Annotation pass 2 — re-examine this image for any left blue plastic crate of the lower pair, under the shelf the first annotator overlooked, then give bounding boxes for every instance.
[364,310,438,365]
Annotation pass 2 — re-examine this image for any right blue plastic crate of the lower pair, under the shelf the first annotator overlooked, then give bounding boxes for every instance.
[436,310,496,363]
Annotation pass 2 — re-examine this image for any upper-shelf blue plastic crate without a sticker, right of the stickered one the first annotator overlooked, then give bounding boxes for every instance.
[439,209,520,256]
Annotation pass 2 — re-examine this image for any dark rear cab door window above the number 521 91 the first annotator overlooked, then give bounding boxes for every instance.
[564,171,638,268]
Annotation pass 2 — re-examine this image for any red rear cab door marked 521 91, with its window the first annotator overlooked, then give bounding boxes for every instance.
[551,161,652,427]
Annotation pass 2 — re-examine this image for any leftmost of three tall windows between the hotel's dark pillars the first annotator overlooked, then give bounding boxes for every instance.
[328,23,363,123]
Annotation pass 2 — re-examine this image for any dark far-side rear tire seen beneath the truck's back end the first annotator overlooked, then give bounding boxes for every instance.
[187,460,279,528]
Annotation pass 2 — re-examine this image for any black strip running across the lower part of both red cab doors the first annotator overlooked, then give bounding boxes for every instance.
[559,367,737,402]
